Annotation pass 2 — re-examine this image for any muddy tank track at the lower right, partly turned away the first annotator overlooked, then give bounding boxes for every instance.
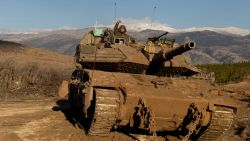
[198,107,234,141]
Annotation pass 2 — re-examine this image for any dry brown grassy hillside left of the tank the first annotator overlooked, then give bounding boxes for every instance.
[0,41,73,99]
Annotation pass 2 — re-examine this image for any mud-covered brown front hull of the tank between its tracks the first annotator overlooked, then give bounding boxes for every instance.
[79,70,235,135]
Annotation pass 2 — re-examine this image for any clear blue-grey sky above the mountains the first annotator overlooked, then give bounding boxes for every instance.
[0,0,250,29]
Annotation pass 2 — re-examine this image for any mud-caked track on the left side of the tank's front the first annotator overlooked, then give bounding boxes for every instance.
[88,89,119,137]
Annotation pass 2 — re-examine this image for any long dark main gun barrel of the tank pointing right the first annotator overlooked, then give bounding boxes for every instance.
[163,41,195,61]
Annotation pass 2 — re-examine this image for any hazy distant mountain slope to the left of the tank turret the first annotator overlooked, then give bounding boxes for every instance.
[0,28,91,55]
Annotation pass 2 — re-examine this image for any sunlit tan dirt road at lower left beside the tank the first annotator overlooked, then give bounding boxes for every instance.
[0,100,175,141]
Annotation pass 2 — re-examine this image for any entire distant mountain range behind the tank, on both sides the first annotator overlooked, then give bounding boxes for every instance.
[0,28,250,64]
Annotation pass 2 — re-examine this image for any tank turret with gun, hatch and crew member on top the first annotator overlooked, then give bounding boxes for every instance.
[76,24,199,76]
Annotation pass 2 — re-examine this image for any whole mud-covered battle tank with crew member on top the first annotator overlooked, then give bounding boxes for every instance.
[59,21,237,141]
